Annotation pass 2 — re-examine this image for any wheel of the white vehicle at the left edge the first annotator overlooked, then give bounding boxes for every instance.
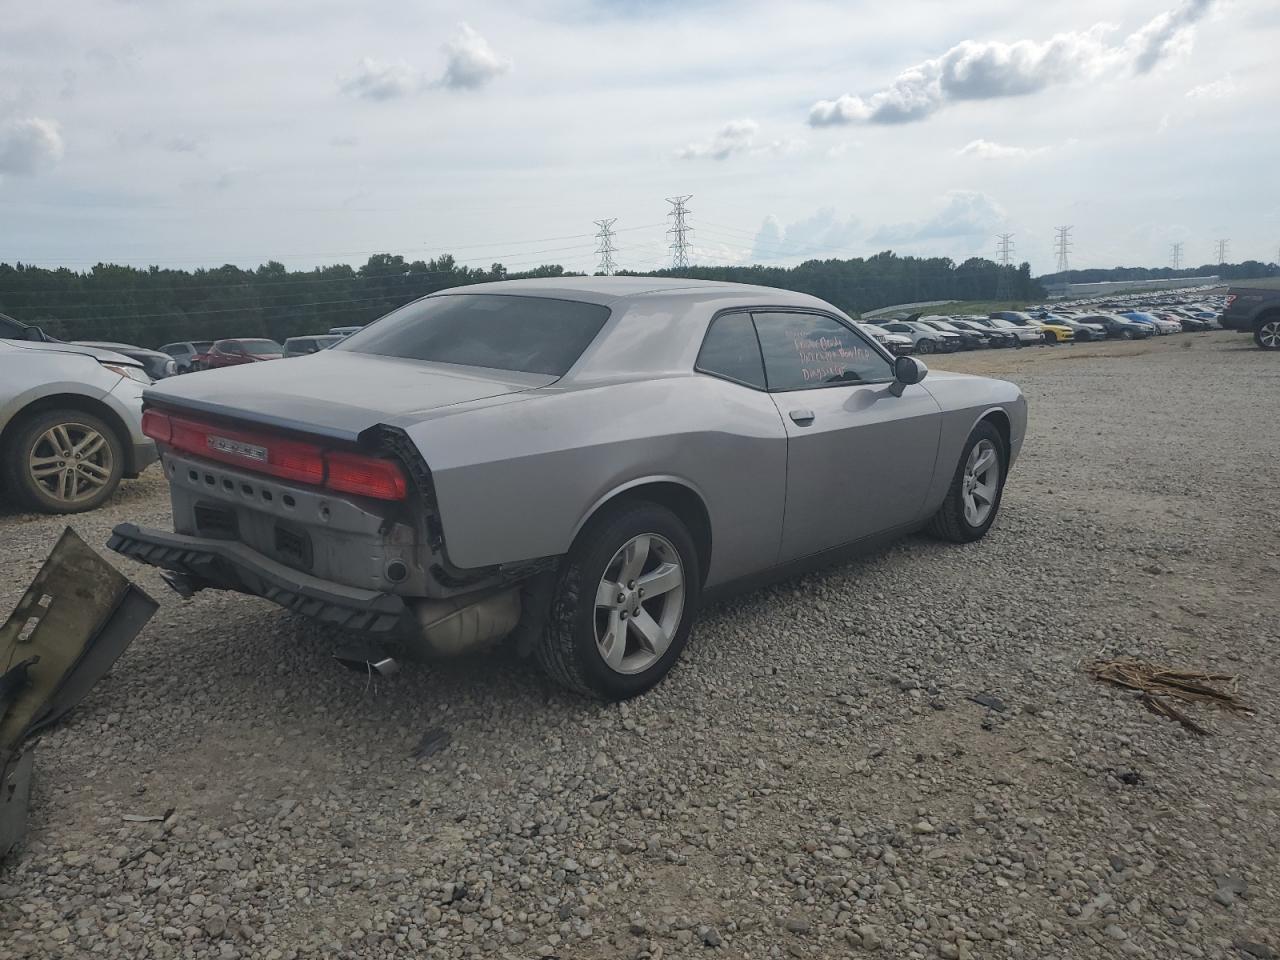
[0,410,124,513]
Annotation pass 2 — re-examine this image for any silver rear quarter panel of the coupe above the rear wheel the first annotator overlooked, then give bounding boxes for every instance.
[406,374,786,585]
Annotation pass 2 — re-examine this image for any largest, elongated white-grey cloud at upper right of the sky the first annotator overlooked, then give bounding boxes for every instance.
[809,0,1215,127]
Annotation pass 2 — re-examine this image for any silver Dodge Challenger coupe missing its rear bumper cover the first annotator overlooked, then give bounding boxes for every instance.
[110,278,1027,699]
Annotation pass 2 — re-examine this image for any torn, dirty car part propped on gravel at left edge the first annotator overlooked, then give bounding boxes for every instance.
[0,527,157,860]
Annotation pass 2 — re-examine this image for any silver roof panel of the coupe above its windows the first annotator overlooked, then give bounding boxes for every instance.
[430,276,831,310]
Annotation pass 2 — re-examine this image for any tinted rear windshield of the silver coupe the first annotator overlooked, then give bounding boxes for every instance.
[333,293,609,376]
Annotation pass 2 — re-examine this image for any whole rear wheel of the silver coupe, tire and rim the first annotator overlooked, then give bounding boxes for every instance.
[538,500,701,700]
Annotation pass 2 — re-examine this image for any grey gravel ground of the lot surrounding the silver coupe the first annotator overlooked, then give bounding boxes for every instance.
[0,333,1280,960]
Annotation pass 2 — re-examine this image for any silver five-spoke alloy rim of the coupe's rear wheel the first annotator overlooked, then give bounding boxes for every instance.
[595,534,685,673]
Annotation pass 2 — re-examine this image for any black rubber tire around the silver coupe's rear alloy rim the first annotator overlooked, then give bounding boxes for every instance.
[536,500,701,700]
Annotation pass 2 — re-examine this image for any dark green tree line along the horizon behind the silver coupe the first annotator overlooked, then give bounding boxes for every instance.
[0,251,1044,347]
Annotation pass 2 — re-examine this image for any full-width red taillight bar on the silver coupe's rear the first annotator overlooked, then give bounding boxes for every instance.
[142,410,408,500]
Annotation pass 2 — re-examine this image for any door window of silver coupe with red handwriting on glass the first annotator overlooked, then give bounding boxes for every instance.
[753,314,893,390]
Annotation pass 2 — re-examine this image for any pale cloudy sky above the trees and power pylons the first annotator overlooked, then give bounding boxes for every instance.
[0,0,1280,274]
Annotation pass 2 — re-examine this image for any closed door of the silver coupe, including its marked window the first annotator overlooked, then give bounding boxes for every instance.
[753,310,942,562]
